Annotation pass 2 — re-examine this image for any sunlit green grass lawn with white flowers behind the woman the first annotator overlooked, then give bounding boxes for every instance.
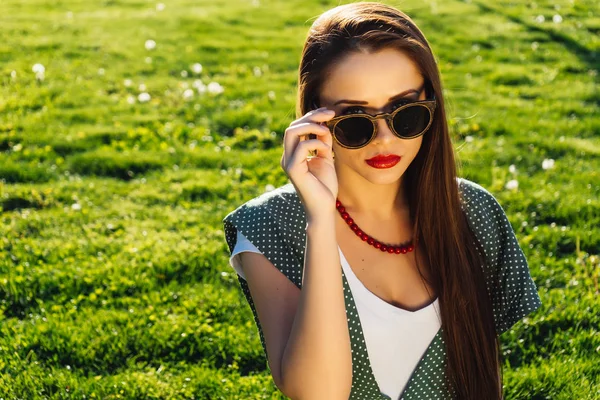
[0,0,600,400]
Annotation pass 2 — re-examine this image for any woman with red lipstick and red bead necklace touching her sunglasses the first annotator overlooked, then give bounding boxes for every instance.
[224,2,541,399]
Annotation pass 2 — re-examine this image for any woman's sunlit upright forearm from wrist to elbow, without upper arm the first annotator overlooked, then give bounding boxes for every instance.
[281,218,352,399]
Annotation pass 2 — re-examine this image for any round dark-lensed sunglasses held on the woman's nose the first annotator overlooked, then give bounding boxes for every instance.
[314,86,436,149]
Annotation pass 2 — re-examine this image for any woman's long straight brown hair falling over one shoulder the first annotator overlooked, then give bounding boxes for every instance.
[296,2,502,400]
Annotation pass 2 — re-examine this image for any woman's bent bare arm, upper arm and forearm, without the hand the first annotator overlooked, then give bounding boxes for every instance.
[242,216,352,400]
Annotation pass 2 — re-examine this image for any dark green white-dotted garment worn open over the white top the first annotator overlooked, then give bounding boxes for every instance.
[223,178,541,400]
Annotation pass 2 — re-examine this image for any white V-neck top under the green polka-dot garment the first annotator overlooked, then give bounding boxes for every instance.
[229,230,441,399]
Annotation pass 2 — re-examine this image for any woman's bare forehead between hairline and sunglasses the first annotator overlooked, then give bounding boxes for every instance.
[319,48,423,105]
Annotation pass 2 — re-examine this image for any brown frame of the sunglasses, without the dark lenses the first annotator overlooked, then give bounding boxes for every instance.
[325,96,437,149]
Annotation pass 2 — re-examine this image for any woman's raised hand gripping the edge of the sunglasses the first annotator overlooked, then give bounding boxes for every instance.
[281,107,338,220]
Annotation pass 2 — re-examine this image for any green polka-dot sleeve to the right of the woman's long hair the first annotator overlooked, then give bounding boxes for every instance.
[461,179,542,335]
